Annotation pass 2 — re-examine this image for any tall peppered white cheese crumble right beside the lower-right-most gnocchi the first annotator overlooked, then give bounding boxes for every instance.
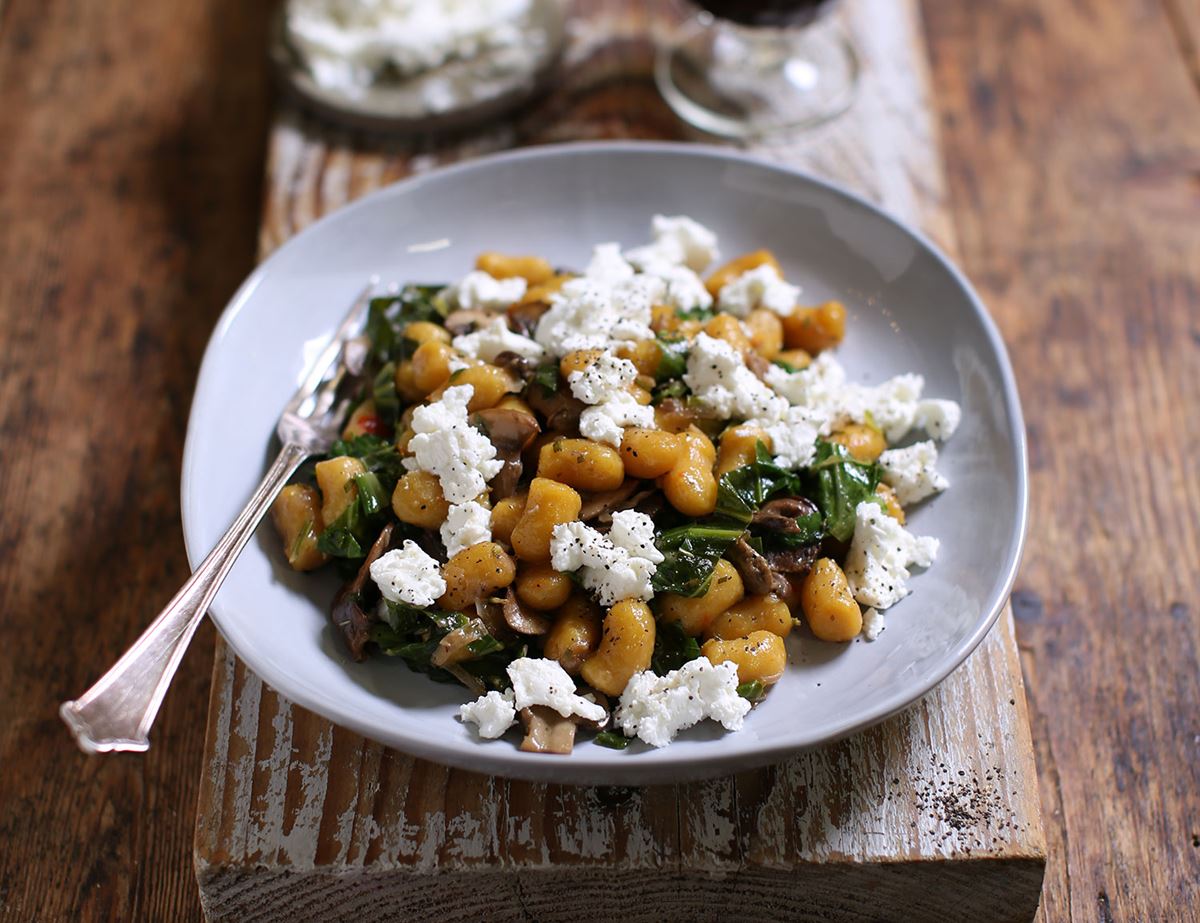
[844,501,940,609]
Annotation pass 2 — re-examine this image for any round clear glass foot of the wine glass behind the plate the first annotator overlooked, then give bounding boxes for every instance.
[654,14,859,138]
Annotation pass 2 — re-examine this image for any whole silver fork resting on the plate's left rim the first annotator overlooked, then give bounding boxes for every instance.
[59,280,376,753]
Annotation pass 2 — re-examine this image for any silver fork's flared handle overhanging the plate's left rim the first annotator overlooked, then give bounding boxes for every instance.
[59,443,310,753]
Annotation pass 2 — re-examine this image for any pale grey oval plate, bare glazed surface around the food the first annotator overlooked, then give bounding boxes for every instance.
[182,143,1026,784]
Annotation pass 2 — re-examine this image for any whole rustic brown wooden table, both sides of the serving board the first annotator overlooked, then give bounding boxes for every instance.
[0,0,1200,921]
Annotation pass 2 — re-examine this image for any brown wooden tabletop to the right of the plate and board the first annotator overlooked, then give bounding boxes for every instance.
[925,0,1200,921]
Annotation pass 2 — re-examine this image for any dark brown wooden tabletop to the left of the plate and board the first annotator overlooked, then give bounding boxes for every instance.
[0,0,269,923]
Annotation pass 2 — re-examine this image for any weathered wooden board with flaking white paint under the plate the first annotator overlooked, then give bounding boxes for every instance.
[196,0,1045,923]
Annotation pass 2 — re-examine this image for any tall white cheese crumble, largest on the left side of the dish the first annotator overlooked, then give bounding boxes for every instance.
[404,384,504,504]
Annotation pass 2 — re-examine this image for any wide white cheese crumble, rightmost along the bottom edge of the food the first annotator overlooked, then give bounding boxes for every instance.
[613,657,750,747]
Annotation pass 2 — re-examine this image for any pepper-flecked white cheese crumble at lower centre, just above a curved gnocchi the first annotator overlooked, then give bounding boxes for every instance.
[550,510,662,606]
